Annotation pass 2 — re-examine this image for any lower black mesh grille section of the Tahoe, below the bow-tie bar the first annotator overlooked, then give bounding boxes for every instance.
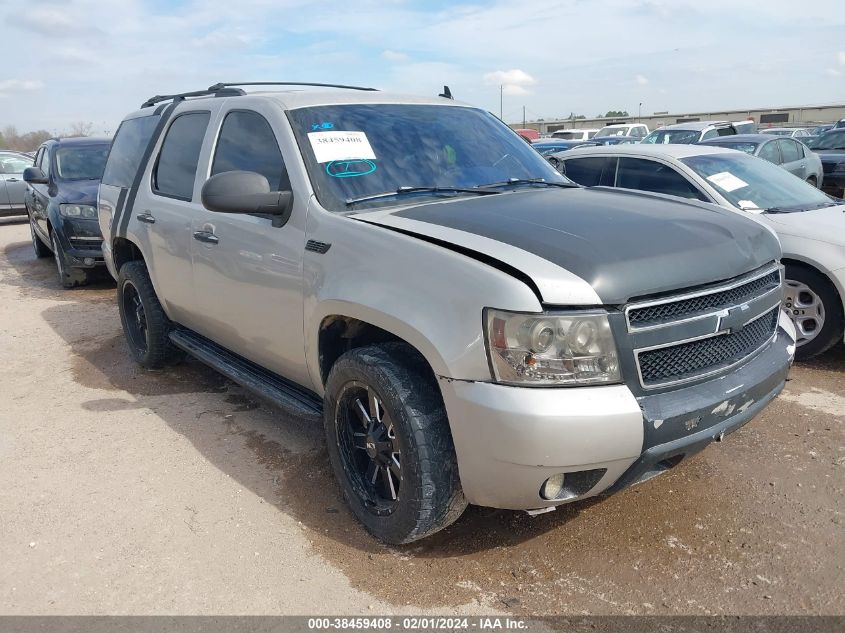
[637,306,779,387]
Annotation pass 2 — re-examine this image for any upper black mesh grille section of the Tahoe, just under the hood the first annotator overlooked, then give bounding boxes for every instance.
[628,270,780,329]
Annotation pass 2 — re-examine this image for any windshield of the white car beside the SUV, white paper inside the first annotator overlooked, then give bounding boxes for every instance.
[681,154,832,211]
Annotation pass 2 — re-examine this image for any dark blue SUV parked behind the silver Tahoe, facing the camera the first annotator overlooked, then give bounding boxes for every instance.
[23,138,110,288]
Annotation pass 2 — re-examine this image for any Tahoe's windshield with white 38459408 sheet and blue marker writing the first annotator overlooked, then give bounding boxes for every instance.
[288,104,569,211]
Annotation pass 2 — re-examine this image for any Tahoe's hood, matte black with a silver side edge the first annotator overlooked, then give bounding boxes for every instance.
[355,188,780,305]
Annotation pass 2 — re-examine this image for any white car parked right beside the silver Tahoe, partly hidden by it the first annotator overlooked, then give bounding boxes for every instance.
[557,144,845,359]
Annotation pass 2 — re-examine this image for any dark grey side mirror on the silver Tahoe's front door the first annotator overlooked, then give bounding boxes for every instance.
[200,171,293,227]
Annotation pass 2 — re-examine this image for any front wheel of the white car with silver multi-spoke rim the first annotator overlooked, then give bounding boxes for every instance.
[783,264,845,360]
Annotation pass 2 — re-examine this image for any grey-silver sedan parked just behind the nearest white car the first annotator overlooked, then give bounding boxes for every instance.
[702,134,824,189]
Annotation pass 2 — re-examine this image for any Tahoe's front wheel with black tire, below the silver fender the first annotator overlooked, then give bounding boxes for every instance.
[323,343,467,544]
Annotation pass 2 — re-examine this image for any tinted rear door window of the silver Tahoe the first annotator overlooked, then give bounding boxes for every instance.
[153,112,211,200]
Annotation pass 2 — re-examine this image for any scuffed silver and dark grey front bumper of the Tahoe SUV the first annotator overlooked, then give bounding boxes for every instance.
[440,315,795,510]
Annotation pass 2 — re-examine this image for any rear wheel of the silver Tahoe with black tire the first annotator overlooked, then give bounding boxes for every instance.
[117,261,184,369]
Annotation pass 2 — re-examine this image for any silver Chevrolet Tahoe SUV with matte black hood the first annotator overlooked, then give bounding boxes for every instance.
[98,84,795,543]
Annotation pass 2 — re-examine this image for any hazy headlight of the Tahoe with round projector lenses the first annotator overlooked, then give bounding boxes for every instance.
[484,308,621,386]
